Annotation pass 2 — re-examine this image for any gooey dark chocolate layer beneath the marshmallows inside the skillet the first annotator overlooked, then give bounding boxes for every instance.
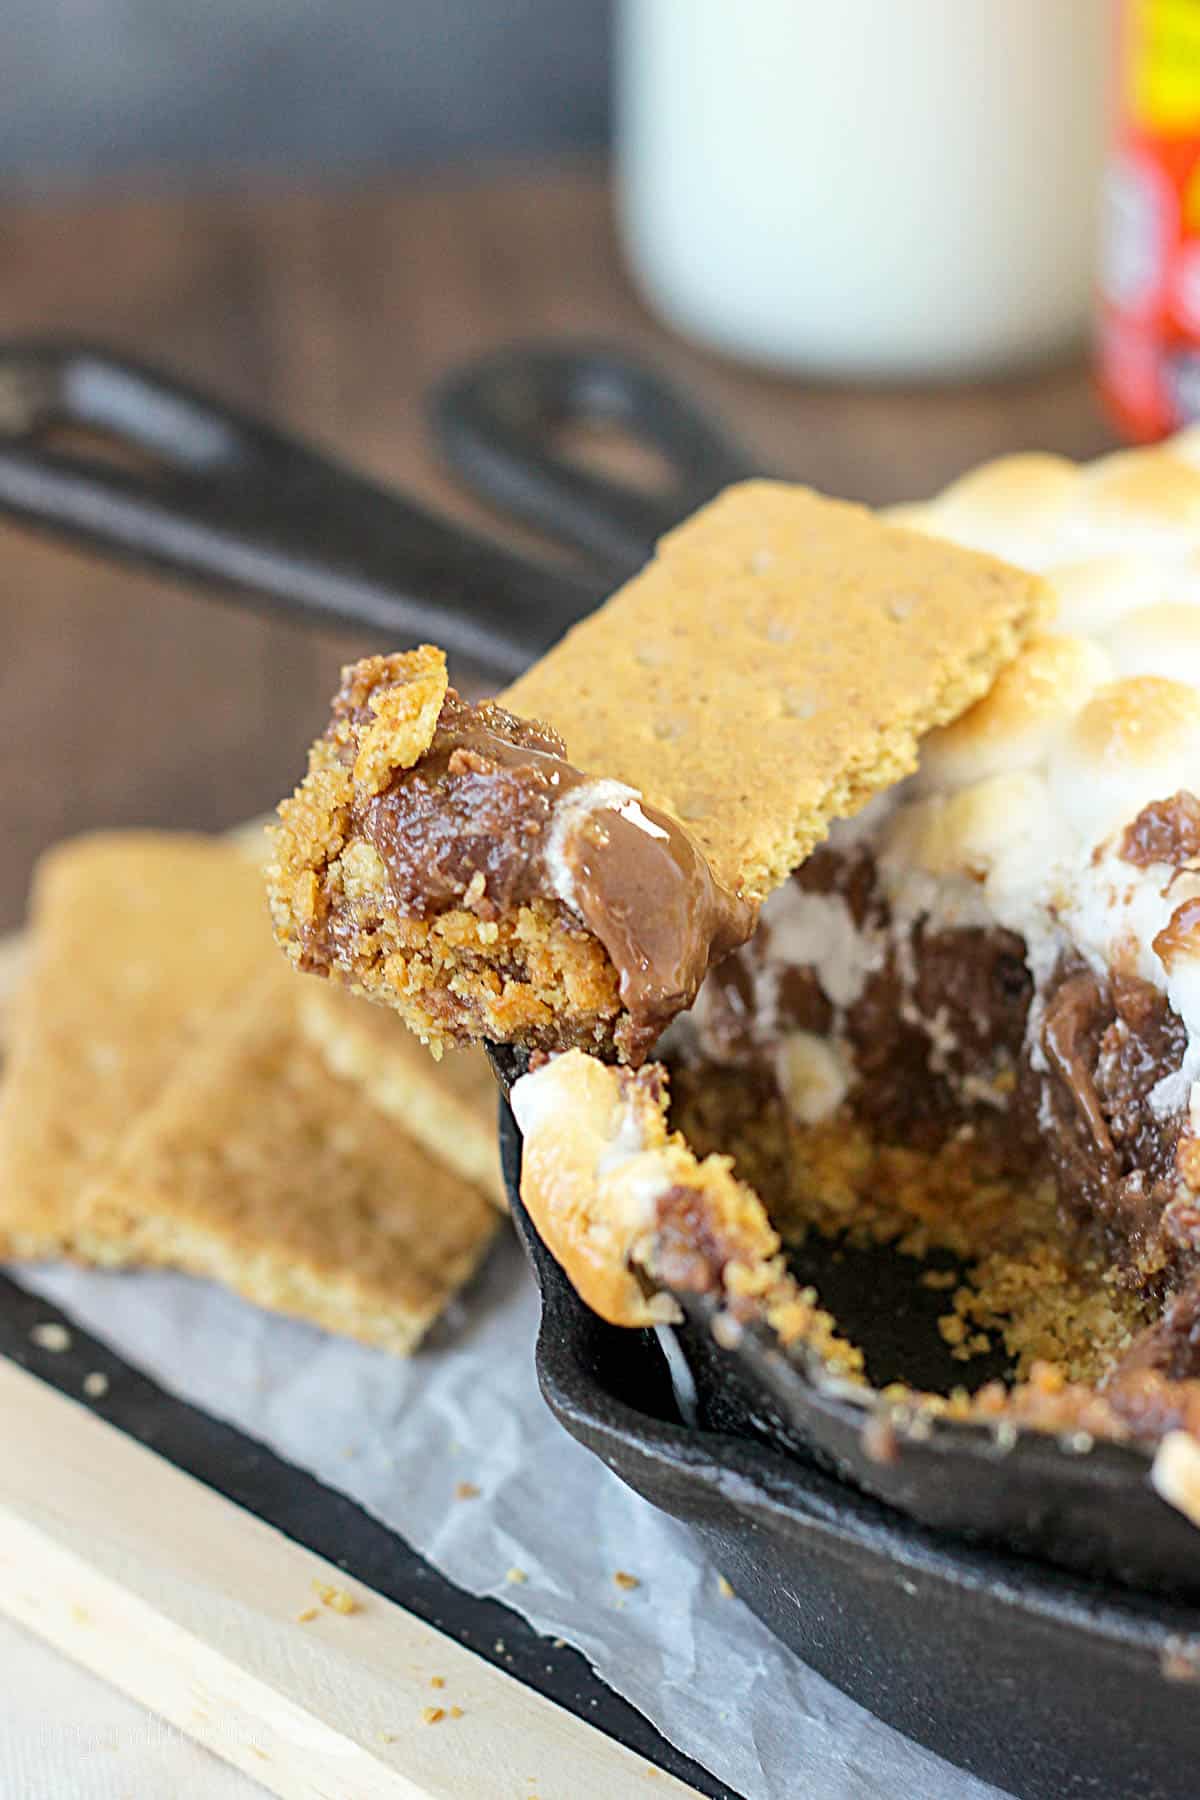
[680,835,1200,1375]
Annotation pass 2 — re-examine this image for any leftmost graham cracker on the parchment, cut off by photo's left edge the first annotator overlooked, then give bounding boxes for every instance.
[0,832,273,1258]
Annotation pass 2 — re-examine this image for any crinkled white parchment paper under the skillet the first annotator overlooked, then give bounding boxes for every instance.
[13,1240,997,1800]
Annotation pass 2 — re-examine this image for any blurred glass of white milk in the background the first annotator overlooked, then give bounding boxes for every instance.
[617,0,1114,376]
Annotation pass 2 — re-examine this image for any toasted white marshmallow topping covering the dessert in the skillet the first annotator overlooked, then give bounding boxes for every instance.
[860,439,1200,1108]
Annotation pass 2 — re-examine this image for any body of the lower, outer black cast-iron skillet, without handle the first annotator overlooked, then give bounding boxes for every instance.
[502,1107,1200,1800]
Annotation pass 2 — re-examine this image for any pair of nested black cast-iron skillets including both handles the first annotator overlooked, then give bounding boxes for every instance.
[0,344,1200,1796]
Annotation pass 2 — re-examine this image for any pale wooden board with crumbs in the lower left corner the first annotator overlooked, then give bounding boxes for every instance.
[0,938,708,1800]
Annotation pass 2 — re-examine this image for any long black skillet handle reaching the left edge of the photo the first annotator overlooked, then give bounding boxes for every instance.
[0,342,608,677]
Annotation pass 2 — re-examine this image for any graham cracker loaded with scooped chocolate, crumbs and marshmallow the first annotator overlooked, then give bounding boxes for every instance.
[270,481,1042,1062]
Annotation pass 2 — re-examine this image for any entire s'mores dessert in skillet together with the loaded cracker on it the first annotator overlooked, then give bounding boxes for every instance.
[268,446,1200,1461]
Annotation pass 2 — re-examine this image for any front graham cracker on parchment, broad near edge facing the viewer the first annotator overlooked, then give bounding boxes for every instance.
[76,959,498,1354]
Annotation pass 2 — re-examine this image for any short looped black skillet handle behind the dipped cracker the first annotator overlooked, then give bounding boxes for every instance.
[432,346,759,580]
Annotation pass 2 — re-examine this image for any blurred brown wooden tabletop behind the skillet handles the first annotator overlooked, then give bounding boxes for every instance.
[0,166,1110,925]
